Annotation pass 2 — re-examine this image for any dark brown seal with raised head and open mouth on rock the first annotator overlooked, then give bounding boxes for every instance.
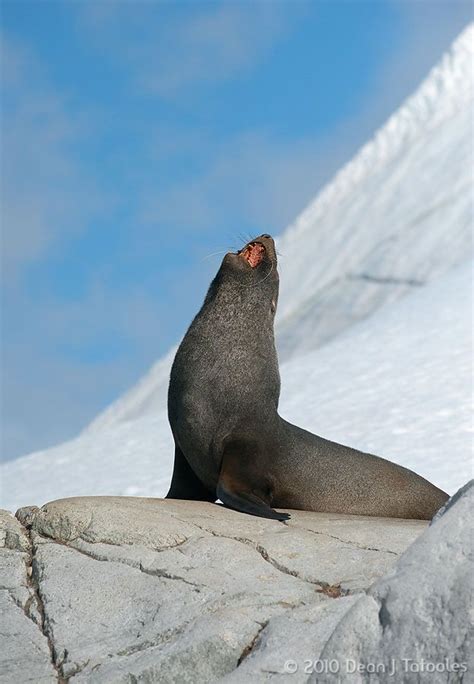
[167,235,448,520]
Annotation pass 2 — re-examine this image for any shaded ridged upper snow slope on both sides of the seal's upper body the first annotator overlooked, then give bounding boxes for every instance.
[87,25,474,430]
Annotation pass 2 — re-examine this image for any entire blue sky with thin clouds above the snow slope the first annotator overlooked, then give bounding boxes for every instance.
[1,0,472,458]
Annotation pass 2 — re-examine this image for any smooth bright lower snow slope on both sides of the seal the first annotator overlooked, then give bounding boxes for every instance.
[2,261,473,510]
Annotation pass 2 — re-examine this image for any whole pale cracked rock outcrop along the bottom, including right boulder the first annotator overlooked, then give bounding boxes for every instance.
[0,484,469,683]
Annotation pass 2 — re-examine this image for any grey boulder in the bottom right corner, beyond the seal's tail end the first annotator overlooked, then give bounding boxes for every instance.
[313,481,474,684]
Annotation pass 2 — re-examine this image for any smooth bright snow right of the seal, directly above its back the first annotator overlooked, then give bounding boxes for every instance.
[280,261,473,493]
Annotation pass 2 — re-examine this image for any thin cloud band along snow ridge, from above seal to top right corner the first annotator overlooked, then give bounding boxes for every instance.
[134,6,470,246]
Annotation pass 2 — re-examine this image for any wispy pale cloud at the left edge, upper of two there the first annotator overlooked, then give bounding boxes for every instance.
[1,36,105,279]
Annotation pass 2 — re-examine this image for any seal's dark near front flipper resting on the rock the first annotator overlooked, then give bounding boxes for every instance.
[217,439,290,521]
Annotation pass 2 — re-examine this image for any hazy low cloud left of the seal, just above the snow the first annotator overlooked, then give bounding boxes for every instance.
[1,272,171,457]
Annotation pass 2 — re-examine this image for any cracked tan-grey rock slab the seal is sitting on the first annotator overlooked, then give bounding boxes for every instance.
[1,497,427,683]
